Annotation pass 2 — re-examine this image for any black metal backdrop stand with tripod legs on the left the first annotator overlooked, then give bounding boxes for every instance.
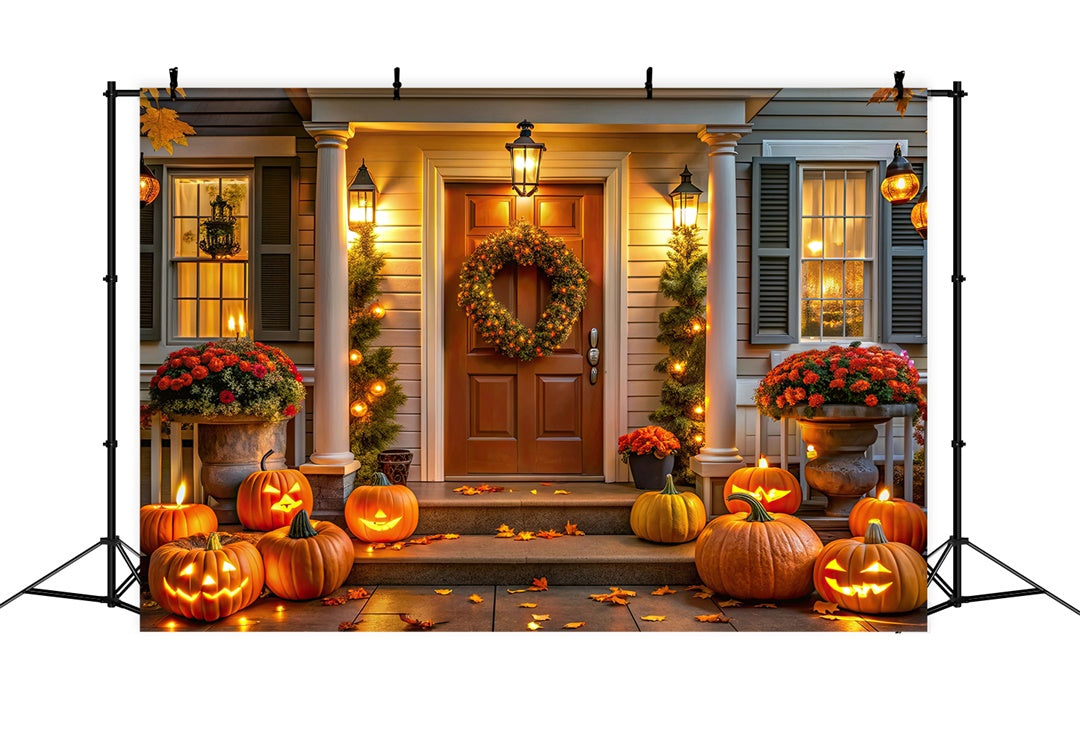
[0,82,141,614]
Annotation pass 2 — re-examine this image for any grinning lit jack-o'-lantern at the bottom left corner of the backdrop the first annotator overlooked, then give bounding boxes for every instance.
[147,532,266,621]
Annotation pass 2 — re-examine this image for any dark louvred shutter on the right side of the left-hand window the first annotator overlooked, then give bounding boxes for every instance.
[252,157,300,340]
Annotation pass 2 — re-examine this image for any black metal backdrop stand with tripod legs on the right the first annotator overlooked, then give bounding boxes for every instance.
[927,82,1080,615]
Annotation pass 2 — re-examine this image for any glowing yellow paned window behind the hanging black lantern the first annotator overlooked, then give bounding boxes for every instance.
[168,172,252,339]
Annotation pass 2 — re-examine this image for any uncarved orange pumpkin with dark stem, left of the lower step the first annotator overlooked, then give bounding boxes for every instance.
[255,509,354,600]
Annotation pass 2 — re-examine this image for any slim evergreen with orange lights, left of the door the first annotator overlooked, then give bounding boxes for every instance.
[349,224,405,479]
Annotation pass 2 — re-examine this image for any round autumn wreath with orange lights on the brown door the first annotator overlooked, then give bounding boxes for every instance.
[458,223,589,361]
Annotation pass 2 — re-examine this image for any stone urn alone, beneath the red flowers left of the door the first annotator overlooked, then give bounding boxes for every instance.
[171,415,288,524]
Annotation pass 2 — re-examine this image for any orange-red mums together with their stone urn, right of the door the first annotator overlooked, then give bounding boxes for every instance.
[754,343,927,517]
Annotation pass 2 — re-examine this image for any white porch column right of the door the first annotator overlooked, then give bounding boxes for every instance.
[691,125,751,509]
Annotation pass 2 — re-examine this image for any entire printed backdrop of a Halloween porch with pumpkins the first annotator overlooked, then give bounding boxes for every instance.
[139,85,928,632]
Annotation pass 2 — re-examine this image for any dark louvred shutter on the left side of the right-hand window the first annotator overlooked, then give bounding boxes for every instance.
[750,157,799,344]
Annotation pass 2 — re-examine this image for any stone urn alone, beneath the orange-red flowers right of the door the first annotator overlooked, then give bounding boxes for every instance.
[784,404,917,517]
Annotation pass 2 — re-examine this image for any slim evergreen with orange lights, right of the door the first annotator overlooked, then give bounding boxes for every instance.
[649,226,708,484]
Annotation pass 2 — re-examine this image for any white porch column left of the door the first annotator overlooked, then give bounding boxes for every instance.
[306,123,354,466]
